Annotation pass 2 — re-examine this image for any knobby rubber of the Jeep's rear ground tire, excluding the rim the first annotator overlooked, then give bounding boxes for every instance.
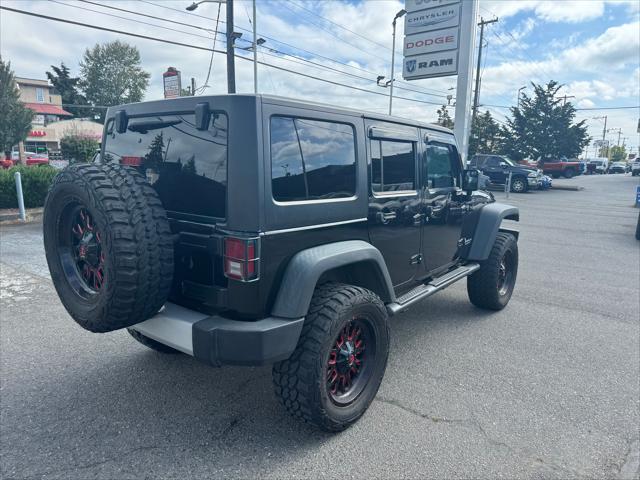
[272,283,389,432]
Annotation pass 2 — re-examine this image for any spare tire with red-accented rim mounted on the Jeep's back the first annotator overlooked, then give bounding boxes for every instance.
[43,164,173,332]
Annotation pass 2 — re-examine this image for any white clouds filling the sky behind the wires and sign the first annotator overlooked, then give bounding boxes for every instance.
[0,0,640,153]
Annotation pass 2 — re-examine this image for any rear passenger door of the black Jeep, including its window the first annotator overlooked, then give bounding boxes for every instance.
[365,120,422,288]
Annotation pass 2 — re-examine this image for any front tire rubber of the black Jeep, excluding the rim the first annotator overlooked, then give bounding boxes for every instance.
[467,232,518,310]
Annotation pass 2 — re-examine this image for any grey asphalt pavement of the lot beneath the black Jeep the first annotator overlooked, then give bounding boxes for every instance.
[0,175,640,479]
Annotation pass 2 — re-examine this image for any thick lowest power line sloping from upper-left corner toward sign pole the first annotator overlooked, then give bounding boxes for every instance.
[0,5,439,105]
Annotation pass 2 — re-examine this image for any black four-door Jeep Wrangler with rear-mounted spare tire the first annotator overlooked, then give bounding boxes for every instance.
[44,95,518,431]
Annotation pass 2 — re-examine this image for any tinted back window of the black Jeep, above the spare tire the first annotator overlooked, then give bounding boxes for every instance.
[103,113,228,218]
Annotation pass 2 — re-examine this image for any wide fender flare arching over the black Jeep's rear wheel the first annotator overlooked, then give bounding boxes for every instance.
[271,240,396,318]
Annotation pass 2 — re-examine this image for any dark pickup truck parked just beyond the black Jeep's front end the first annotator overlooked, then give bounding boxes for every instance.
[469,154,542,193]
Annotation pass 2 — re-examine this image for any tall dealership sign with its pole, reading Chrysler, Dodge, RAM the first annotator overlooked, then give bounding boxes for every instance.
[402,0,478,159]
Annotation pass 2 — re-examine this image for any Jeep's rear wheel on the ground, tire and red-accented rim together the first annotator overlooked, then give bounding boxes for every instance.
[273,283,389,432]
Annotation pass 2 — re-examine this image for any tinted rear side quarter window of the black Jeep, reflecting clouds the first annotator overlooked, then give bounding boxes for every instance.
[270,116,356,202]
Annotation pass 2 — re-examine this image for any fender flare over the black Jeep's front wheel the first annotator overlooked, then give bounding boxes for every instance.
[460,202,520,261]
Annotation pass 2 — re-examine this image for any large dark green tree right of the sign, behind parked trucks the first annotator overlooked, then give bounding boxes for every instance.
[501,80,590,162]
